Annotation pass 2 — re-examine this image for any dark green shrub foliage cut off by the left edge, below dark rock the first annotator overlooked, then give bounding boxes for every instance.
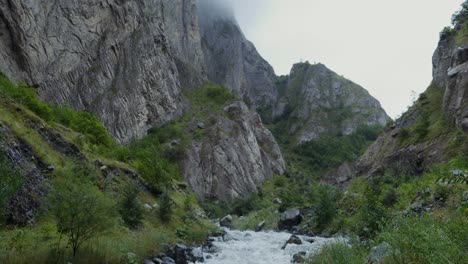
[0,153,23,225]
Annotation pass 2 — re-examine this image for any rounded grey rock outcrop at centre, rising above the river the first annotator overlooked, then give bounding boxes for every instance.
[182,101,285,200]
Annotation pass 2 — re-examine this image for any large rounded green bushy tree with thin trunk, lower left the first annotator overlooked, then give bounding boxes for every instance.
[49,177,116,257]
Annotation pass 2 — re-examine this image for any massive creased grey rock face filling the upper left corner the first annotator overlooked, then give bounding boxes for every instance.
[0,0,185,142]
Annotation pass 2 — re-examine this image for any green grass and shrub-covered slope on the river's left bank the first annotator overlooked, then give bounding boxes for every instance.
[0,75,218,263]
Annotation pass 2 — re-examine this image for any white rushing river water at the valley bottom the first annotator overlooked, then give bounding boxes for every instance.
[203,230,344,264]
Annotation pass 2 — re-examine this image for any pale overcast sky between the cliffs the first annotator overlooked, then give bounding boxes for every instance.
[229,0,463,118]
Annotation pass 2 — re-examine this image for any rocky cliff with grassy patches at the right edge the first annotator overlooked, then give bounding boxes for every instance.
[356,22,468,175]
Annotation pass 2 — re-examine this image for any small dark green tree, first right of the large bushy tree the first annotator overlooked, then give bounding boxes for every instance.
[119,186,143,229]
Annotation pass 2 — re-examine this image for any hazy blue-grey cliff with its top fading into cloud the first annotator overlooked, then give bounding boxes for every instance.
[199,0,277,108]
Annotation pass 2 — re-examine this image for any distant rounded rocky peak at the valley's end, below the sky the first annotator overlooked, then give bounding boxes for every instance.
[273,62,390,143]
